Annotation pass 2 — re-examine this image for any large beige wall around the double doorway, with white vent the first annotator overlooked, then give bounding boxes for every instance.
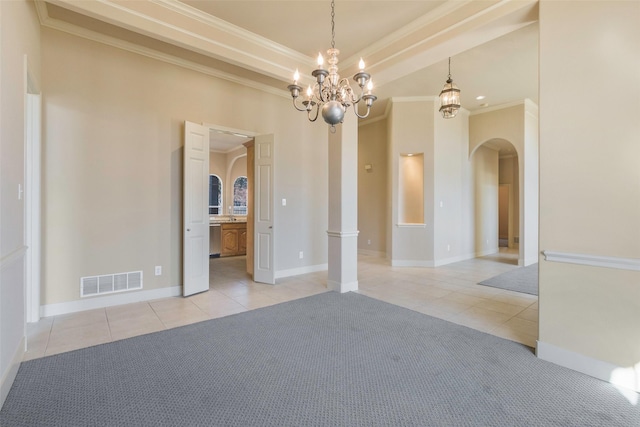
[42,29,327,304]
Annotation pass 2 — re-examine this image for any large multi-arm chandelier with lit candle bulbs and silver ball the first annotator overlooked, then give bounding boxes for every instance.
[287,0,377,131]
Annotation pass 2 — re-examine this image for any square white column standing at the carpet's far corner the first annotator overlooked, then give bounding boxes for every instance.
[327,115,358,292]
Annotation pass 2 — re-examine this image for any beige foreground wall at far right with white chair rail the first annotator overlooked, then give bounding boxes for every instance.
[538,1,640,384]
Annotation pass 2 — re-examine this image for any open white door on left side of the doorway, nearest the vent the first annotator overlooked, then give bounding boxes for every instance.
[182,122,209,296]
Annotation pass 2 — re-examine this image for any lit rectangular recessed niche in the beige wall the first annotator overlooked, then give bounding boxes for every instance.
[398,153,424,224]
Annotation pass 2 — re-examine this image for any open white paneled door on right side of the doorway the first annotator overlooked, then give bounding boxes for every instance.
[253,135,275,284]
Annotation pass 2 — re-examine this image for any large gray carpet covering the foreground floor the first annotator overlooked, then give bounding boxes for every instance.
[0,292,640,427]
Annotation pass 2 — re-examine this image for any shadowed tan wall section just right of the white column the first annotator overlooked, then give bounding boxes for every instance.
[358,120,391,255]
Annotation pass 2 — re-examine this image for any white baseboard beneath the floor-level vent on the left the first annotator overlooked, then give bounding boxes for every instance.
[40,286,182,317]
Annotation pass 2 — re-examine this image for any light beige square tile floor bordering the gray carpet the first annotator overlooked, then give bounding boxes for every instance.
[24,250,538,360]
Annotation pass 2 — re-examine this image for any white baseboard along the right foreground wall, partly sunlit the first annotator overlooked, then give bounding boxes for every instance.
[536,341,640,398]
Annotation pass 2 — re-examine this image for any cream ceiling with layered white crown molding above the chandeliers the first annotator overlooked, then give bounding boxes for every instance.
[36,0,538,151]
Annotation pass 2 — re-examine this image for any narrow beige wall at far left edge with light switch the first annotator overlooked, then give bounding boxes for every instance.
[0,1,41,406]
